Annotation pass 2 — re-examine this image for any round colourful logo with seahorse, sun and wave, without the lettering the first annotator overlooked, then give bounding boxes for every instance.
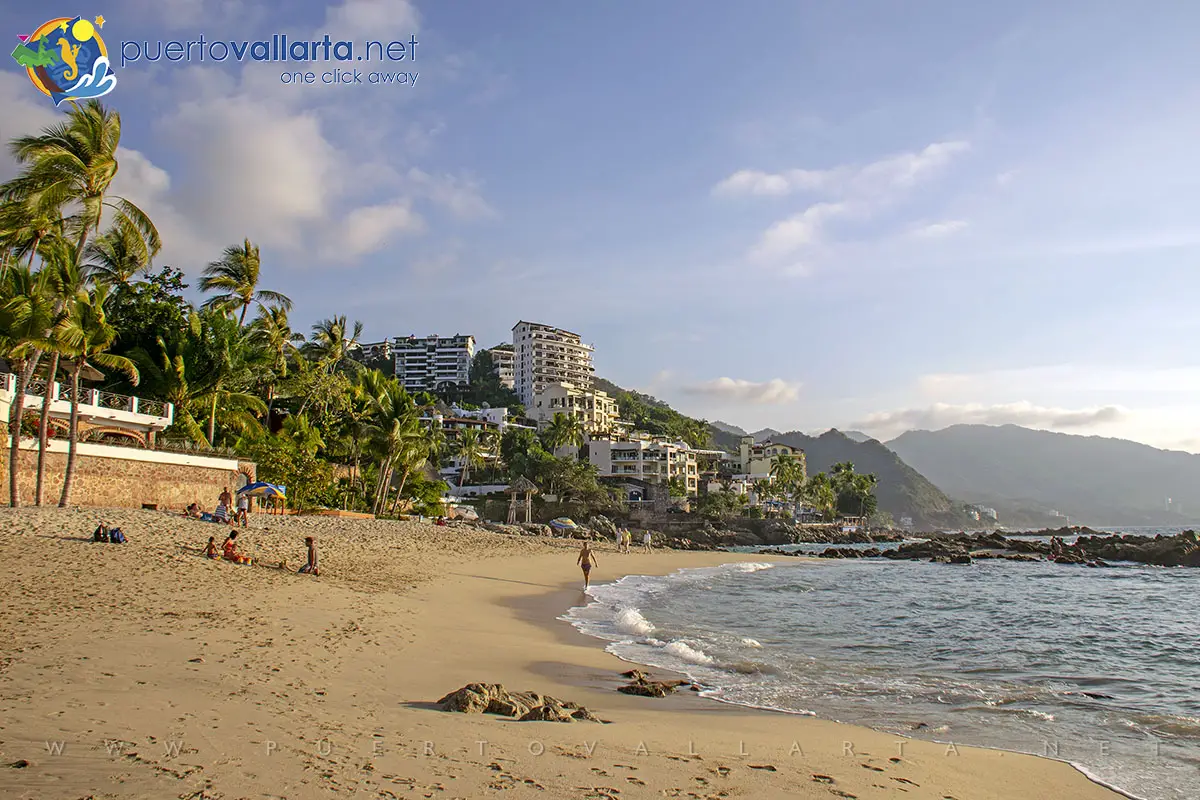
[12,16,116,106]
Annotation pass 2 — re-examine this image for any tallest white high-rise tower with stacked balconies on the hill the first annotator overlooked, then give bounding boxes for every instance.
[512,320,594,407]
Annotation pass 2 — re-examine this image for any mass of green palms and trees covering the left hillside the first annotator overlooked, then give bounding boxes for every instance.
[0,101,597,515]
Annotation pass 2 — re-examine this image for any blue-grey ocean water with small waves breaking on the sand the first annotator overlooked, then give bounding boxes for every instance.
[563,560,1200,800]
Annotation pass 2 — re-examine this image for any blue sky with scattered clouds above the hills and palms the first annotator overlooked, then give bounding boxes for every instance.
[0,0,1200,452]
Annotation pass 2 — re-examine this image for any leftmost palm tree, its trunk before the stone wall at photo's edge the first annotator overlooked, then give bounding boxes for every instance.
[0,265,55,509]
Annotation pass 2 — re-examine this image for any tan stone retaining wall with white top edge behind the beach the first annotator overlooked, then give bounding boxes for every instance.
[0,437,256,510]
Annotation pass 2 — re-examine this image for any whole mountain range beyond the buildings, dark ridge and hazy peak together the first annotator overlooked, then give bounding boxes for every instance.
[602,381,1200,529]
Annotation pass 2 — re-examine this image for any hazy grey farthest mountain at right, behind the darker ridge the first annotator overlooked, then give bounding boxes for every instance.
[887,425,1200,527]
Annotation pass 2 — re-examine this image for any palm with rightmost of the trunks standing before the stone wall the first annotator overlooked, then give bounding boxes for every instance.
[59,285,140,507]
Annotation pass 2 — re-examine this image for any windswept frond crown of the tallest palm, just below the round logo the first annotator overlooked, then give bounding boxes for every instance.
[0,100,162,260]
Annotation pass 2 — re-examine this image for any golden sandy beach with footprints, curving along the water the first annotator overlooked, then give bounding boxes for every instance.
[0,509,1118,800]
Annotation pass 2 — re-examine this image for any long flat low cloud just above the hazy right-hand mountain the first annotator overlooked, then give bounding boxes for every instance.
[852,401,1129,433]
